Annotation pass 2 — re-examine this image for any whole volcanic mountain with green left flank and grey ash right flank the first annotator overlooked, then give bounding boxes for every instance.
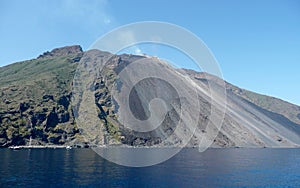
[0,45,300,147]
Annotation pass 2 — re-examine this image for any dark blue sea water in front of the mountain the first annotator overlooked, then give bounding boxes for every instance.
[0,149,300,187]
